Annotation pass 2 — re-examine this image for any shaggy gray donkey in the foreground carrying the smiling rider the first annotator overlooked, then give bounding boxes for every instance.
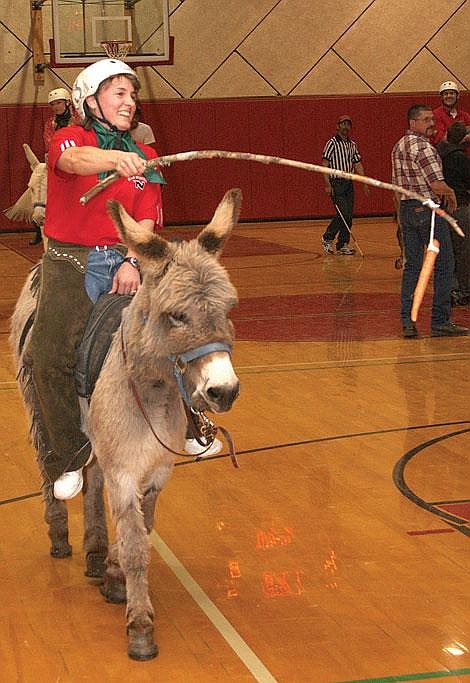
[10,190,241,660]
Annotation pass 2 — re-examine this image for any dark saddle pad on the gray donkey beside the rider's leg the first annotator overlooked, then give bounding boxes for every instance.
[75,294,132,401]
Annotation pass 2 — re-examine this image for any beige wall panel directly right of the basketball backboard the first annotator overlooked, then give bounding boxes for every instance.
[159,0,275,97]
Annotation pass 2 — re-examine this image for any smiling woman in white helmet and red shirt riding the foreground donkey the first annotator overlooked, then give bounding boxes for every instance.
[26,59,165,500]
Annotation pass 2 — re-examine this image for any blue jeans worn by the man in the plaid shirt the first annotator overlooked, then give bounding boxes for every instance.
[400,199,454,327]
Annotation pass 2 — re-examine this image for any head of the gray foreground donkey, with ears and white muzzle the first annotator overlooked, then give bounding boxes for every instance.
[109,190,241,413]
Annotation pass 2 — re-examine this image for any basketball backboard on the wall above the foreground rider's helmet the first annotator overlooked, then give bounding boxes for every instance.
[51,0,170,66]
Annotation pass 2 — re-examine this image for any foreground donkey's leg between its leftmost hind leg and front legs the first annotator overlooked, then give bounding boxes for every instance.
[83,458,108,577]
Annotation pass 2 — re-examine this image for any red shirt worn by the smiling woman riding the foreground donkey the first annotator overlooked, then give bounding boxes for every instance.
[44,126,163,247]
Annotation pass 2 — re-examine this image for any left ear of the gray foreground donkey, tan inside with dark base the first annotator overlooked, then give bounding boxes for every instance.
[108,199,170,261]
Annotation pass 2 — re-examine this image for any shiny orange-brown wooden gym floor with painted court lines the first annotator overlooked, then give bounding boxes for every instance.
[0,219,470,683]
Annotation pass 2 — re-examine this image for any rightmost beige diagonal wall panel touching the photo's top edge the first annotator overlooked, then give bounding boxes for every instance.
[335,0,461,92]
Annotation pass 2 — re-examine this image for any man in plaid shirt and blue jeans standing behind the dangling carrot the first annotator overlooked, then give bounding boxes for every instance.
[392,104,470,339]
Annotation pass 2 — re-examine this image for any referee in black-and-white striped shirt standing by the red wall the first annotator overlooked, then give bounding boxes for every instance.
[322,114,369,256]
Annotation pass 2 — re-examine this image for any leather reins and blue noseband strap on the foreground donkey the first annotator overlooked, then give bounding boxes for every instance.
[121,324,240,468]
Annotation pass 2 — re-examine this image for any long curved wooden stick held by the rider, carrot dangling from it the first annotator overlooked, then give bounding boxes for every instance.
[80,149,465,237]
